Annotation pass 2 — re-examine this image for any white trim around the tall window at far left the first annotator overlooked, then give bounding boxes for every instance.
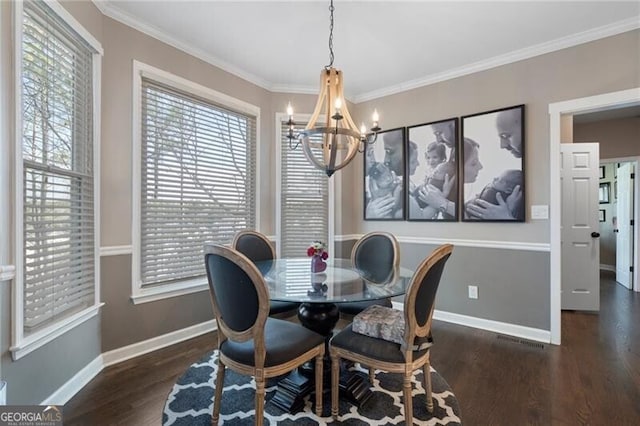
[9,0,104,361]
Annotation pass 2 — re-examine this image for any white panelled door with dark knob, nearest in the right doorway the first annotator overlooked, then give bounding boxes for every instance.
[560,143,600,311]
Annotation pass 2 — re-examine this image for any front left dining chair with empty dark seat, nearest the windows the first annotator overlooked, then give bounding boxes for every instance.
[204,244,325,425]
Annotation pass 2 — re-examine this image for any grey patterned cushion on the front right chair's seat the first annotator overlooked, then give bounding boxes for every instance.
[353,305,433,350]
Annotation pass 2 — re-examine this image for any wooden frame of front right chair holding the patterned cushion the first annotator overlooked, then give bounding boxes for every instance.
[329,244,453,425]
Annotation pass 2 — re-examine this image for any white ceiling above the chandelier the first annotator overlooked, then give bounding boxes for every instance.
[93,0,640,102]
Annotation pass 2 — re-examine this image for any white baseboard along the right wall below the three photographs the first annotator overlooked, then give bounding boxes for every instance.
[393,302,551,343]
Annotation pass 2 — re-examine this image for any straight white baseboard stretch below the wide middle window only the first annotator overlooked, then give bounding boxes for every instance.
[102,320,218,367]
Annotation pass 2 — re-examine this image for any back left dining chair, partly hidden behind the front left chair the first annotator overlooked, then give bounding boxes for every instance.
[231,229,300,318]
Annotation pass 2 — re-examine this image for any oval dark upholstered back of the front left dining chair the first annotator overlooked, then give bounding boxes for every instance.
[205,244,269,341]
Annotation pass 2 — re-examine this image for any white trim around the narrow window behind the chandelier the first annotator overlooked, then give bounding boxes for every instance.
[275,112,342,256]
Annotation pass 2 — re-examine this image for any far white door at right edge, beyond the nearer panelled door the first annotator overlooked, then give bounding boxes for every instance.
[614,163,633,289]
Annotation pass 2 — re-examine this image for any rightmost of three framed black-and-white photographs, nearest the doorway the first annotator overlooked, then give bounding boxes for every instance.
[460,105,525,222]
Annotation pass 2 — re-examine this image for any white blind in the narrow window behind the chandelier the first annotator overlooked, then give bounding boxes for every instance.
[278,123,329,257]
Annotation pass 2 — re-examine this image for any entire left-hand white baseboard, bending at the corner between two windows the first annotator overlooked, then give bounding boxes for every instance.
[41,320,218,405]
